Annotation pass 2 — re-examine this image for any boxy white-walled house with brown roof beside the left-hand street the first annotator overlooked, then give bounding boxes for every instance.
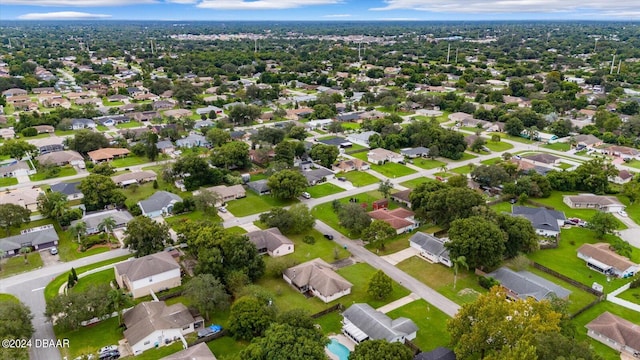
[113,251,182,299]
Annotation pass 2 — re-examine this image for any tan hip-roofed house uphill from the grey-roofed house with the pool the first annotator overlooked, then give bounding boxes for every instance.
[282,258,353,303]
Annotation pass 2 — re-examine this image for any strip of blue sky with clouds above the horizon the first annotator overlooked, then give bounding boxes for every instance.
[0,0,640,21]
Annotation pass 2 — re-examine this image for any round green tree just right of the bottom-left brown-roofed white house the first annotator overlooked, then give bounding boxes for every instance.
[229,296,275,340]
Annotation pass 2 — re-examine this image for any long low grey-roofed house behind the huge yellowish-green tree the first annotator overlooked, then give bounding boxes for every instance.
[486,267,571,301]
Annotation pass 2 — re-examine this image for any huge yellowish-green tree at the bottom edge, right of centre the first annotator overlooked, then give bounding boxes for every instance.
[447,286,561,359]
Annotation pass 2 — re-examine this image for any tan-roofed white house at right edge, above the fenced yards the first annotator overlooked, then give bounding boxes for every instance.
[578,243,640,278]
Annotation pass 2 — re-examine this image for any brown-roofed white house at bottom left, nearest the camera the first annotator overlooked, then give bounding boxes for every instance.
[122,301,198,355]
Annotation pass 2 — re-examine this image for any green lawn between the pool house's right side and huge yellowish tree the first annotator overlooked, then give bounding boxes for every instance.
[387,299,451,351]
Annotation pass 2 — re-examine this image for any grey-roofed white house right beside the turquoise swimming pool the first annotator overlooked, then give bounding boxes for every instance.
[342,303,418,344]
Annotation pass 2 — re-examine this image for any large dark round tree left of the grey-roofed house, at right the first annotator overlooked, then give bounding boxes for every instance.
[445,216,506,269]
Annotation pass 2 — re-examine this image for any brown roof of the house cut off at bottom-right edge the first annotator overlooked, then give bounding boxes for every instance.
[586,311,640,350]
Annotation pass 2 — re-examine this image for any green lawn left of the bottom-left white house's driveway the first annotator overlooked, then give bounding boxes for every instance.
[54,317,124,359]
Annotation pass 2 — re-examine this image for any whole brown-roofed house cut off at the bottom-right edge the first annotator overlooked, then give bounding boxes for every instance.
[585,311,640,357]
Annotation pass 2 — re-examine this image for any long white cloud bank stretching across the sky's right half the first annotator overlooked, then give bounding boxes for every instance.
[369,0,640,16]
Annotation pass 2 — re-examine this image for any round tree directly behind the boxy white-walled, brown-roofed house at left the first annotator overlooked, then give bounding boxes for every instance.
[124,216,171,257]
